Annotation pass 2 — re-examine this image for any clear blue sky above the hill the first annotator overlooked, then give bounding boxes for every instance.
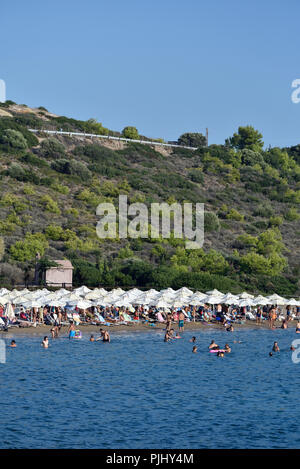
[0,0,300,146]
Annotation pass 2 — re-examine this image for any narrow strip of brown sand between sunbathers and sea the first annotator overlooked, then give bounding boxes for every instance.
[0,321,297,338]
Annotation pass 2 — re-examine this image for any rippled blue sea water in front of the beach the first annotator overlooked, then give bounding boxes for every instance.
[0,327,300,449]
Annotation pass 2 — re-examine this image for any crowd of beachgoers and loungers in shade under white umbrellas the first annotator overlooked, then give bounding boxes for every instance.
[0,298,300,331]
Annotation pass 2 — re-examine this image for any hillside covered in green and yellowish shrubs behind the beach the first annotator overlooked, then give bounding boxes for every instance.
[0,101,300,296]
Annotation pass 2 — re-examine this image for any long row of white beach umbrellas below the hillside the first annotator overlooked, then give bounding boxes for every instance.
[0,286,300,309]
